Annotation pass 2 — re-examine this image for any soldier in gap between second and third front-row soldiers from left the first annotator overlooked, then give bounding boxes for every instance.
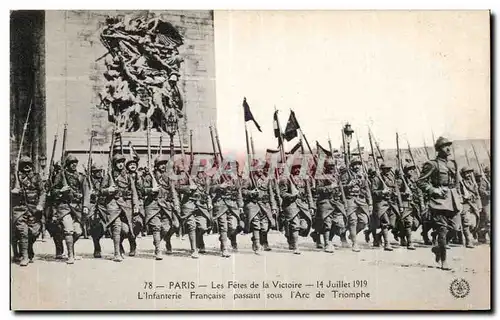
[85,164,107,258]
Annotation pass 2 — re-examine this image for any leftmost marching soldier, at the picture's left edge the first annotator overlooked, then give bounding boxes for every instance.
[11,157,46,266]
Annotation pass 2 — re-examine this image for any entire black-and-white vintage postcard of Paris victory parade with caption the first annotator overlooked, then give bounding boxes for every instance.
[10,10,492,311]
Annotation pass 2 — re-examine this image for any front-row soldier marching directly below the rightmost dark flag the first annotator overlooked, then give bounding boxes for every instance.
[276,165,316,254]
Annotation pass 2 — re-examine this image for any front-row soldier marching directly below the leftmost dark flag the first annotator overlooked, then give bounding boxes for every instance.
[242,160,277,254]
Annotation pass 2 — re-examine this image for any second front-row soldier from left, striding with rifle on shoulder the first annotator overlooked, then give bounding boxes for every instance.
[52,155,90,264]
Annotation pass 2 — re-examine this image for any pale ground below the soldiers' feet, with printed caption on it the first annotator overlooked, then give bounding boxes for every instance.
[11,232,491,310]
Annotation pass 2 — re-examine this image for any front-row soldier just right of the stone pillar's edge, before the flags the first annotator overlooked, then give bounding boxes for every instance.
[210,161,243,258]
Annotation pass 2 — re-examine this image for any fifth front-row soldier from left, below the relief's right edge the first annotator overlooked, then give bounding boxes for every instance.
[177,161,212,259]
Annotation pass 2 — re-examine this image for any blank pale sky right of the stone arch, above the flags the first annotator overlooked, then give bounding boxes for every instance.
[214,11,490,152]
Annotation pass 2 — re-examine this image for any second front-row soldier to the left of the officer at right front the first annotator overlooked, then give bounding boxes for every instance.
[372,163,400,251]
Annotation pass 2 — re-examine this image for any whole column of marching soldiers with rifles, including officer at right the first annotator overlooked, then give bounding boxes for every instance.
[11,115,490,270]
